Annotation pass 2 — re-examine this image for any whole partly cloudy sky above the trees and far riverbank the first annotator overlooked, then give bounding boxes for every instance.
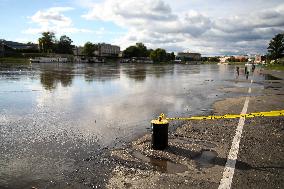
[0,0,284,56]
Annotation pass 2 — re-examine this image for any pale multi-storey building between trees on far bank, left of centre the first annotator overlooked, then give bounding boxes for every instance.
[95,43,120,57]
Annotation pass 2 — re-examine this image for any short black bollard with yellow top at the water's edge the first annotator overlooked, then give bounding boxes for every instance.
[151,116,169,150]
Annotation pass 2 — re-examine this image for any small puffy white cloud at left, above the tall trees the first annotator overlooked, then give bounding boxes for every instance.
[23,7,92,34]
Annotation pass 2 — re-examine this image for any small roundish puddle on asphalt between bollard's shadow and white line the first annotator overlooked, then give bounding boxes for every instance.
[193,150,218,169]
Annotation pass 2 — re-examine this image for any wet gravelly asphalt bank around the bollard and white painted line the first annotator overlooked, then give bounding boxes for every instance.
[107,68,284,188]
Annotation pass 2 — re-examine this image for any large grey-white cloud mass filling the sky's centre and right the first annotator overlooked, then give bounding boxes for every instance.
[82,0,284,54]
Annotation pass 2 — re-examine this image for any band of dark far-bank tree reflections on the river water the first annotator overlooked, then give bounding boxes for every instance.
[37,64,178,91]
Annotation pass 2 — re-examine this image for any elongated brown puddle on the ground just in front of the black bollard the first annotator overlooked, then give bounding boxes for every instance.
[132,151,187,173]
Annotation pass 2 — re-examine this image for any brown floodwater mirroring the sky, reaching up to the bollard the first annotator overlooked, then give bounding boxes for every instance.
[0,64,264,188]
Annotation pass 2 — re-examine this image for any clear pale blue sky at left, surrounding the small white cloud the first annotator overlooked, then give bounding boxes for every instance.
[0,0,126,45]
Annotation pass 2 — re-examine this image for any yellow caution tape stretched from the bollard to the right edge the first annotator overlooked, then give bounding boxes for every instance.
[161,110,284,121]
